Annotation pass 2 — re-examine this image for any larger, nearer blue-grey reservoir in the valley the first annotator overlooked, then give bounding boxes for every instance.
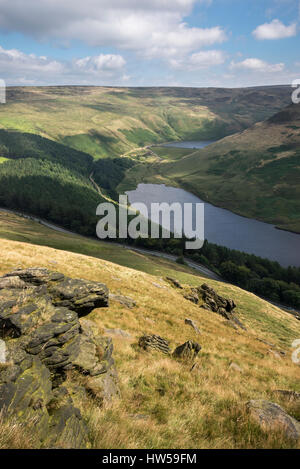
[127,182,300,267]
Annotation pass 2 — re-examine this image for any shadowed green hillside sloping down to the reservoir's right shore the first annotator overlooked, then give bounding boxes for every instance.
[122,105,300,232]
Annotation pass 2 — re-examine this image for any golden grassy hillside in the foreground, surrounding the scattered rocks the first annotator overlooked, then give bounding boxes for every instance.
[0,210,300,448]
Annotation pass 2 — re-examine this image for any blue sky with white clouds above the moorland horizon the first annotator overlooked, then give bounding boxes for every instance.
[0,0,300,87]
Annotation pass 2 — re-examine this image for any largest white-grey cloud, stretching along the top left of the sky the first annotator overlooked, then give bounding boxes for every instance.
[0,0,226,57]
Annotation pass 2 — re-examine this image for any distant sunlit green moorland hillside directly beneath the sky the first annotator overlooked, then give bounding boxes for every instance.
[0,86,290,158]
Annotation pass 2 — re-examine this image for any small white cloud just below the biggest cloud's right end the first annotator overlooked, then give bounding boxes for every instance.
[170,50,225,71]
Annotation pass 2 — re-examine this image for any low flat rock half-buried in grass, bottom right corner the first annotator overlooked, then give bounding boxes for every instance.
[246,399,300,440]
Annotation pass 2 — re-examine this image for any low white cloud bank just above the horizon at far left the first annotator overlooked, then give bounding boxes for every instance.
[0,46,128,85]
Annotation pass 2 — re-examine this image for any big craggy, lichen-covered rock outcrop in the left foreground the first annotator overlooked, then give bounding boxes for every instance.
[0,268,118,448]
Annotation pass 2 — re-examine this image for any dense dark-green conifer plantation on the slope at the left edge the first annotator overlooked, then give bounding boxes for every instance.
[0,158,104,235]
